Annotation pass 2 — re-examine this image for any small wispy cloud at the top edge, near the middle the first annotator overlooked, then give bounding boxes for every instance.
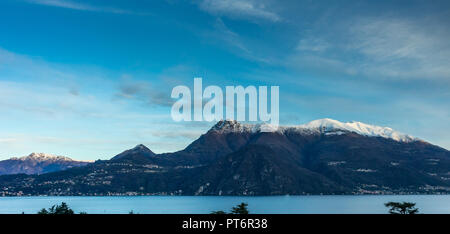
[199,0,281,22]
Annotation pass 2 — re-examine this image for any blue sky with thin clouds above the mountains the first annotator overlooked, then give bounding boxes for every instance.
[0,0,450,160]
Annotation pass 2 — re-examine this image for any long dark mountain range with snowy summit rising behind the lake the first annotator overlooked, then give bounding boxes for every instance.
[0,119,450,196]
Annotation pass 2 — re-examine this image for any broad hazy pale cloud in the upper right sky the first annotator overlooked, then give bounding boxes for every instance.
[289,17,450,81]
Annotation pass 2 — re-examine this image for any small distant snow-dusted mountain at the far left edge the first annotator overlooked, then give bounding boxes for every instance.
[0,153,90,175]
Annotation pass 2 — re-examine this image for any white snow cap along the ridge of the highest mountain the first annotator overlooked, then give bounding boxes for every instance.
[210,118,419,142]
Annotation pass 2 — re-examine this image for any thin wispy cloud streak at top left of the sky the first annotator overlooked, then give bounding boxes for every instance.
[26,0,148,15]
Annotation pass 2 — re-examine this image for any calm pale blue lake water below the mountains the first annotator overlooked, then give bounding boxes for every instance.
[0,195,450,214]
